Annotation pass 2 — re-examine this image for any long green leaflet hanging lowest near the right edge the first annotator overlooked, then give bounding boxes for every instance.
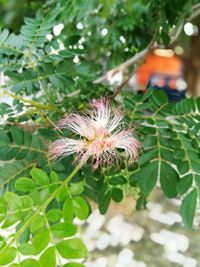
[180,189,197,229]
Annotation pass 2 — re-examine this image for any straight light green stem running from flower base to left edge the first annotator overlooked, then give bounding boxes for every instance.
[0,163,82,253]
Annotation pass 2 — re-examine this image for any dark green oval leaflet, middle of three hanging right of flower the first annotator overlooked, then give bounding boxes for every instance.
[160,162,179,198]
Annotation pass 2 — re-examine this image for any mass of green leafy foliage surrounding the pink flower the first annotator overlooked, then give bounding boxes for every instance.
[0,0,200,267]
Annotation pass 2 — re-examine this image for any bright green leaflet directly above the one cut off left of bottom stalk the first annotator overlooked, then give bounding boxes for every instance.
[32,230,50,255]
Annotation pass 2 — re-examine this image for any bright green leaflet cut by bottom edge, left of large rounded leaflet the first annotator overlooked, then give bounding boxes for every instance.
[39,247,56,267]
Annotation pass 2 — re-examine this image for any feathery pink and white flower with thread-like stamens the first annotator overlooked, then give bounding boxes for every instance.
[50,99,140,168]
